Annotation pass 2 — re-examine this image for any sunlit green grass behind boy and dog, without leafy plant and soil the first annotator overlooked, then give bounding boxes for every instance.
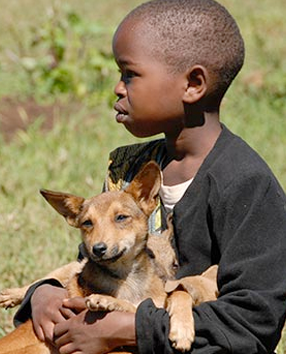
[0,0,286,354]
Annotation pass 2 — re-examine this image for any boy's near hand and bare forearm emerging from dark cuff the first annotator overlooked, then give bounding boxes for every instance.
[54,308,136,354]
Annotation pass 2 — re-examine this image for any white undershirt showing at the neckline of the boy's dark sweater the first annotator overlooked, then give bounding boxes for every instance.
[159,178,194,213]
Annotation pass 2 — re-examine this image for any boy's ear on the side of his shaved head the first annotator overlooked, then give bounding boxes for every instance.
[183,65,209,104]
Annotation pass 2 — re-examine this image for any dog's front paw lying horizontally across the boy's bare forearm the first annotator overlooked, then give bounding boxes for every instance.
[86,294,136,313]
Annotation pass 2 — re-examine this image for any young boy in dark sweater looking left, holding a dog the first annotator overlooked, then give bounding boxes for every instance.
[16,0,286,354]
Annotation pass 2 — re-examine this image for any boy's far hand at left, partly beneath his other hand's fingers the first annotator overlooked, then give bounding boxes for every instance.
[31,284,72,343]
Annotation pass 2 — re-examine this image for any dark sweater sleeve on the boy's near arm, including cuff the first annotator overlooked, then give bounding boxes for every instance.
[136,170,286,354]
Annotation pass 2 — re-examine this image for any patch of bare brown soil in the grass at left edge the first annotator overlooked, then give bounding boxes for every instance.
[0,97,67,142]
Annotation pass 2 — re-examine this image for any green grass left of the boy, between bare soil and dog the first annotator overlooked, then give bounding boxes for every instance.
[0,104,140,334]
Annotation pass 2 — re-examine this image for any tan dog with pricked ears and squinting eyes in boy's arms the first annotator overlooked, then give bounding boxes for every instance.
[0,162,216,354]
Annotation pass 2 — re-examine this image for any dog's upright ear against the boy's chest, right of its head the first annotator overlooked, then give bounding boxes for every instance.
[125,161,161,216]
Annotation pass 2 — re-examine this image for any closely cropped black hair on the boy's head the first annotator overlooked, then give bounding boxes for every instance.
[126,0,245,99]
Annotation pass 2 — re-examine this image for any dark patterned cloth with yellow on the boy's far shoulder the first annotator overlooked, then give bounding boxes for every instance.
[105,139,165,190]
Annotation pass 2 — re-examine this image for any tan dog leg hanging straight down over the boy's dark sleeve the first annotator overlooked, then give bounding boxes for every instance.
[166,290,195,352]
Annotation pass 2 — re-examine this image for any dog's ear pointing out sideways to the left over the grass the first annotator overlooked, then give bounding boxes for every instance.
[40,189,85,227]
